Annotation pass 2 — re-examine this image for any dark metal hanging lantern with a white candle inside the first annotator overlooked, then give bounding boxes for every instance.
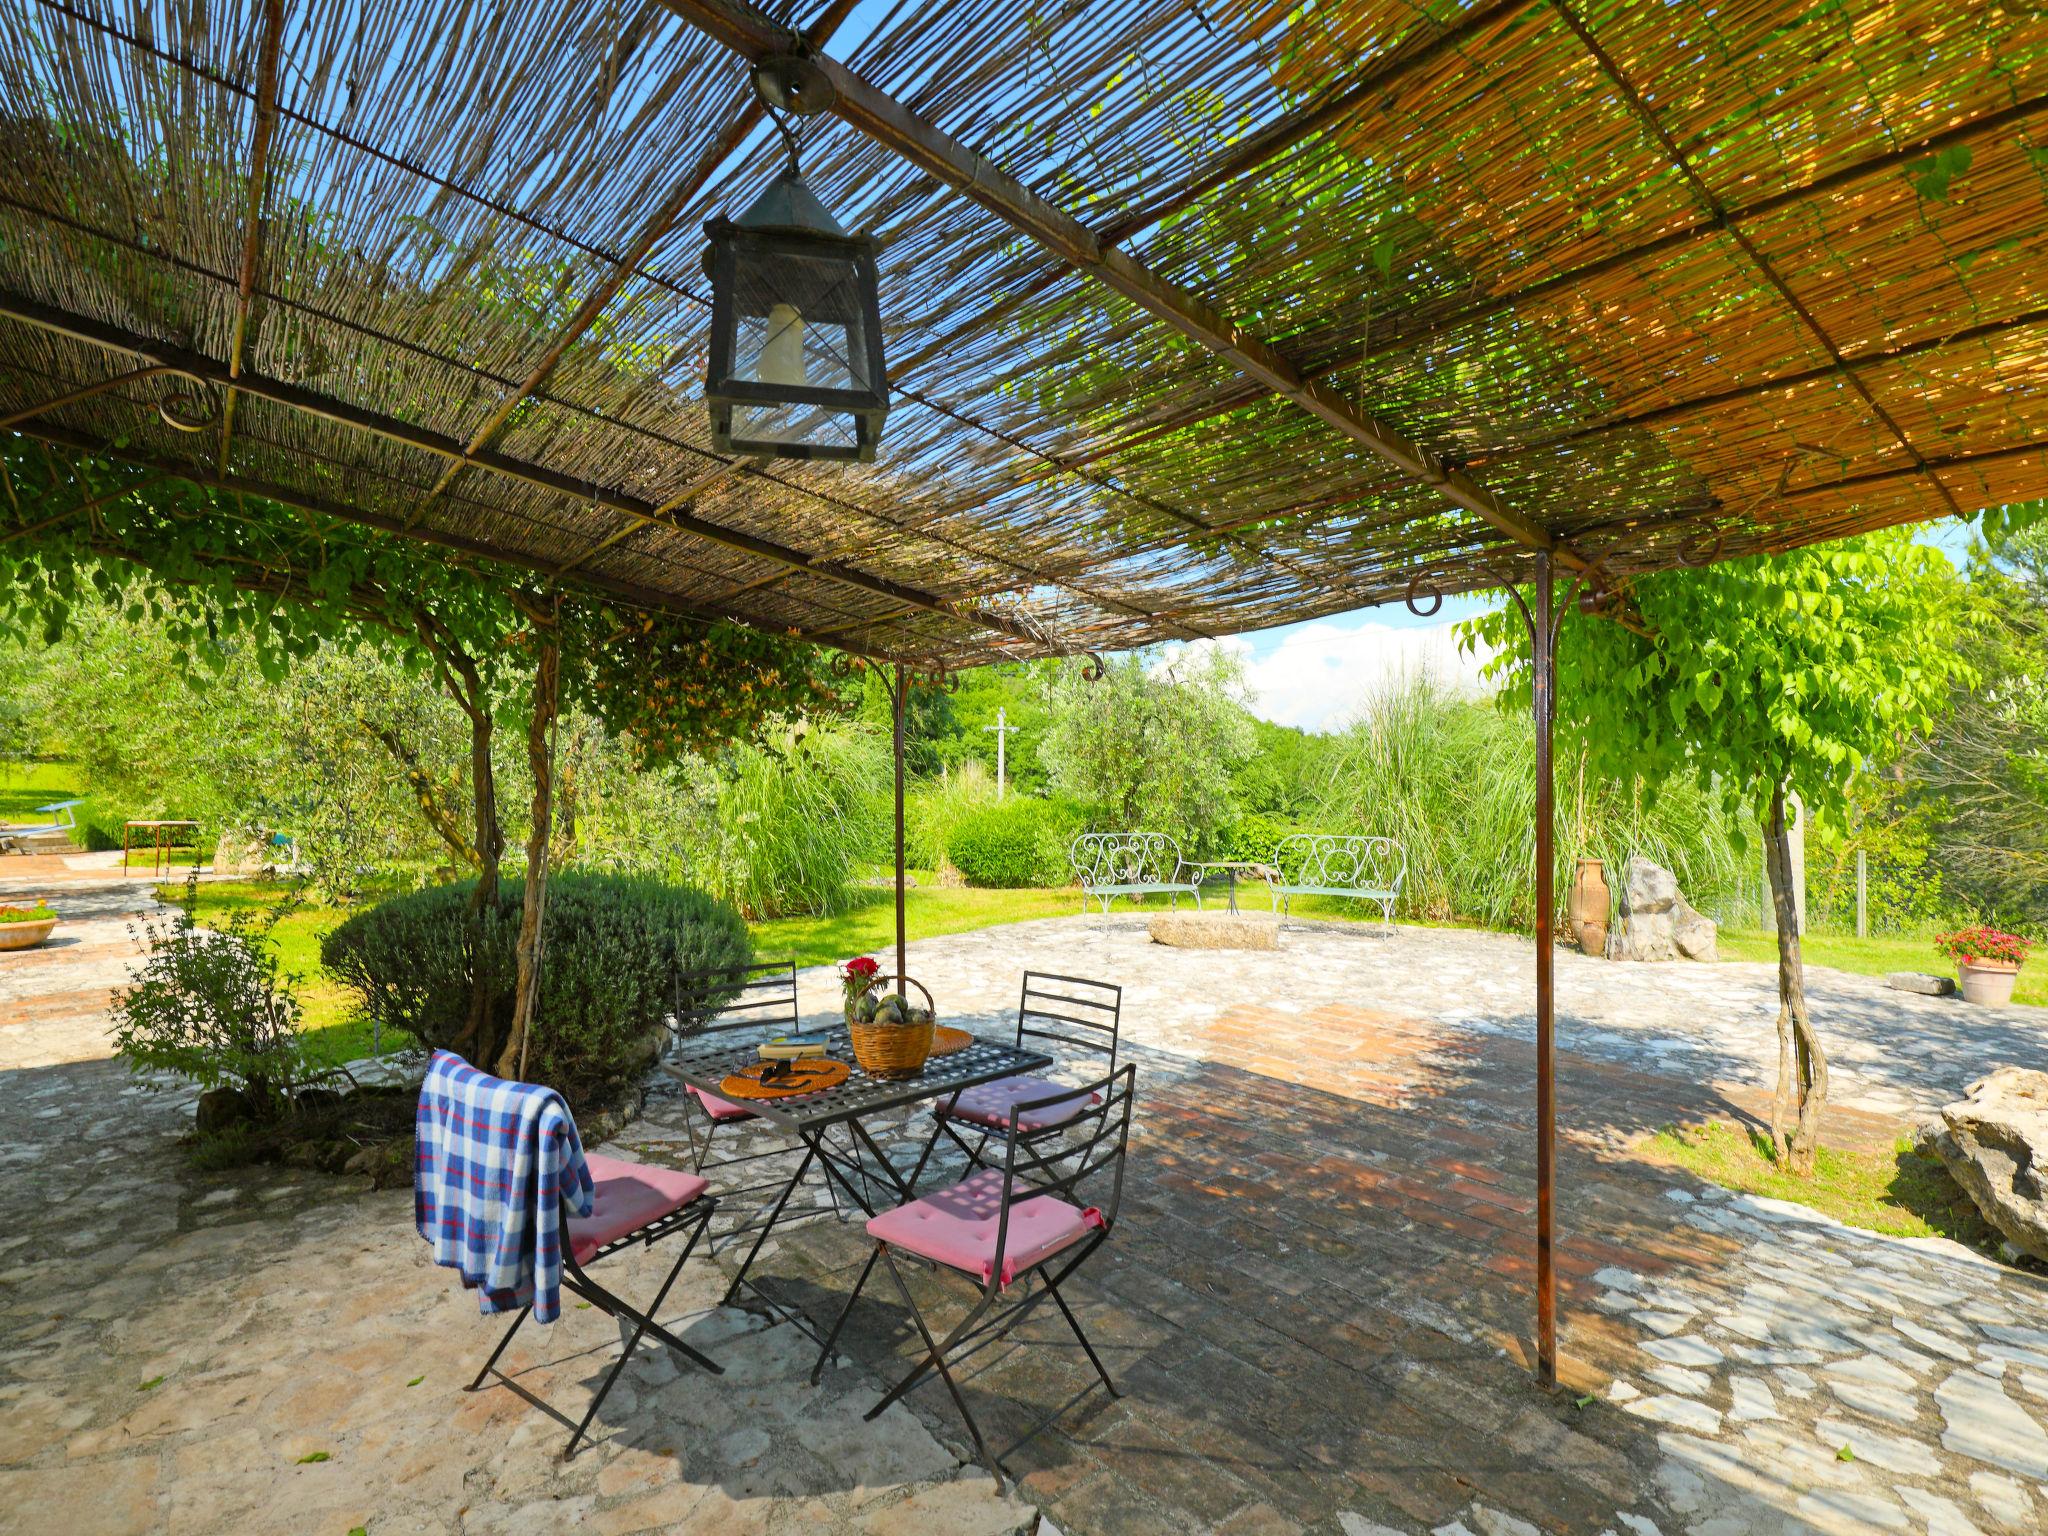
[705,154,889,463]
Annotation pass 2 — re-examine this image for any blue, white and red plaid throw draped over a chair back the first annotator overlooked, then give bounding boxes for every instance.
[412,1051,596,1323]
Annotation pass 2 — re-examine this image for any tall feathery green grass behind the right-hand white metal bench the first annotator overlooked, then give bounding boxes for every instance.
[1305,674,1755,928]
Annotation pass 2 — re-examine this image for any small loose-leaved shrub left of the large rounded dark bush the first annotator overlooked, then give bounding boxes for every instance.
[115,885,324,1118]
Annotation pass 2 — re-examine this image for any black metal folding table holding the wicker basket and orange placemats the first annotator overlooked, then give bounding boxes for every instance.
[666,1026,1053,1321]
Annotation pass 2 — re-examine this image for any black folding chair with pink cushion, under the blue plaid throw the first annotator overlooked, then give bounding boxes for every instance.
[463,1153,725,1460]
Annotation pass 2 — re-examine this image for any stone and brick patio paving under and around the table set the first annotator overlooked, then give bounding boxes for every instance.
[0,866,2048,1536]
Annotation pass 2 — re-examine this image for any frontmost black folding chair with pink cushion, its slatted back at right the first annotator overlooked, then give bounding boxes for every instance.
[811,1065,1137,1485]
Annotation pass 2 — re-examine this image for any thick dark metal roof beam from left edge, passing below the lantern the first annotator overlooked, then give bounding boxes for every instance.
[0,293,1047,649]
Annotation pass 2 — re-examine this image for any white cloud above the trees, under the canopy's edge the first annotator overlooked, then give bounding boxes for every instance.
[1196,621,1491,731]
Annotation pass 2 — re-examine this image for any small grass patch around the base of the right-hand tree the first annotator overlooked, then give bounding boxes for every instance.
[1642,1120,1999,1251]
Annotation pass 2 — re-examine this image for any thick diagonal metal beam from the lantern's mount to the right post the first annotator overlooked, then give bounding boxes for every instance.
[664,0,1583,569]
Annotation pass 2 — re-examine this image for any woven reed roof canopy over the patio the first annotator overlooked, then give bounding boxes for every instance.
[0,0,2048,668]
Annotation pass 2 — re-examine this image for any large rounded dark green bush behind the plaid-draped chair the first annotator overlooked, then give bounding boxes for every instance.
[319,872,752,1106]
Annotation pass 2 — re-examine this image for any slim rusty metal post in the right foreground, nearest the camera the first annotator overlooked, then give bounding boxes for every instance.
[1528,551,1556,1386]
